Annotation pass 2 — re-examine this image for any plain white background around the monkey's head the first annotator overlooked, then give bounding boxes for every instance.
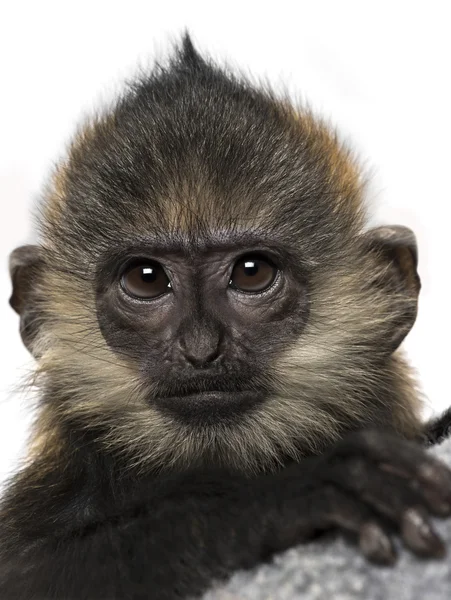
[0,0,451,480]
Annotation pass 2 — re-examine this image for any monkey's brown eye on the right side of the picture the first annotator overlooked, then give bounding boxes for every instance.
[230,254,278,293]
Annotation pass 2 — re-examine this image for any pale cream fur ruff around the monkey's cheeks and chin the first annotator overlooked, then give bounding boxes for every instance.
[28,244,417,471]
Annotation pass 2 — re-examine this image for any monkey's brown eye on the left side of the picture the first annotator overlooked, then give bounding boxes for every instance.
[121,261,171,300]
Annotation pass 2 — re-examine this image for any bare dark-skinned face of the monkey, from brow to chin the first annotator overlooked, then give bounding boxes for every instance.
[97,236,308,422]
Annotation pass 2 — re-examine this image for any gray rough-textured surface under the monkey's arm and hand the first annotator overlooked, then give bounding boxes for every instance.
[204,439,451,600]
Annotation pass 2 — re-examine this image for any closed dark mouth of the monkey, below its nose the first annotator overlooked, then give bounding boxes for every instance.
[153,390,264,424]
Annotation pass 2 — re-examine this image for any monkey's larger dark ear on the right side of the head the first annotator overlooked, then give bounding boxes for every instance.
[364,225,421,352]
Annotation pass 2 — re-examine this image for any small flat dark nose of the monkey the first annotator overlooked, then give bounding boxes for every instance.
[179,324,221,369]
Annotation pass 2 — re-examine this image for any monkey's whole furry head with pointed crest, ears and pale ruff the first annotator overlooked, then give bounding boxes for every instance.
[7,38,419,469]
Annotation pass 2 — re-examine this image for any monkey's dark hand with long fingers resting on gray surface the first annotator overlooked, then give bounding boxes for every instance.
[279,431,451,564]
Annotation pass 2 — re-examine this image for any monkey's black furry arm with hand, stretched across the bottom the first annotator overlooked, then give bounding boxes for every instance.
[0,432,451,600]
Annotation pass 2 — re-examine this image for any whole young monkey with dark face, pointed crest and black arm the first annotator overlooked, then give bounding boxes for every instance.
[0,37,451,600]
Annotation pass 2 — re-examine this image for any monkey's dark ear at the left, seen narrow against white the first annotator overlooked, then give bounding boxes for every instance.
[9,245,43,354]
